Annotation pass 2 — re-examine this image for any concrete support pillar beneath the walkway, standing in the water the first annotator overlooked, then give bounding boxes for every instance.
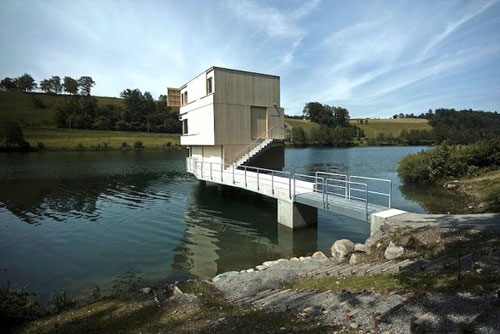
[278,199,318,229]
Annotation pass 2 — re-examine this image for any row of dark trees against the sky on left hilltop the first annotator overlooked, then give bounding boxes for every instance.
[0,73,95,96]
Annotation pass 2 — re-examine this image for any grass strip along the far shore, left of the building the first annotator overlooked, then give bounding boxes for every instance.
[19,128,179,151]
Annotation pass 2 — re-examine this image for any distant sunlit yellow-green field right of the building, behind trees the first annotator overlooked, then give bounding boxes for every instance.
[285,118,431,139]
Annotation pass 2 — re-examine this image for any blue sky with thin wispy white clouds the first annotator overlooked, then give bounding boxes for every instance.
[0,0,500,118]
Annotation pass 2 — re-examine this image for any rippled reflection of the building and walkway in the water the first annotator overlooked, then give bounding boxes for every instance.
[172,183,317,278]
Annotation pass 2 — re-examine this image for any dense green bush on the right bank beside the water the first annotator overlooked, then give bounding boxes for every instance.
[398,140,500,183]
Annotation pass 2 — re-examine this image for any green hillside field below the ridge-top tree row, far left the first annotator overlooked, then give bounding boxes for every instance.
[0,92,123,128]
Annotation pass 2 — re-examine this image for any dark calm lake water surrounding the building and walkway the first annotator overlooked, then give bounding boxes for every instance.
[0,147,424,297]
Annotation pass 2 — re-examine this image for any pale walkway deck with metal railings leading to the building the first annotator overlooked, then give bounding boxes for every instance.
[186,157,392,217]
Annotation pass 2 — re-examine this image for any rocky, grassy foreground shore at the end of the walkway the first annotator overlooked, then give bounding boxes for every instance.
[14,213,500,333]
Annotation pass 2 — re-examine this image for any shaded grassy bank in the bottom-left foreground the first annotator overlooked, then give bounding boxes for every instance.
[17,282,335,334]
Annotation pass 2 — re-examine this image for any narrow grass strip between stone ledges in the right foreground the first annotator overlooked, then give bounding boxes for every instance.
[292,272,497,295]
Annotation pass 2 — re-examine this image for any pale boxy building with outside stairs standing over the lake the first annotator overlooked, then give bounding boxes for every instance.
[167,67,285,169]
